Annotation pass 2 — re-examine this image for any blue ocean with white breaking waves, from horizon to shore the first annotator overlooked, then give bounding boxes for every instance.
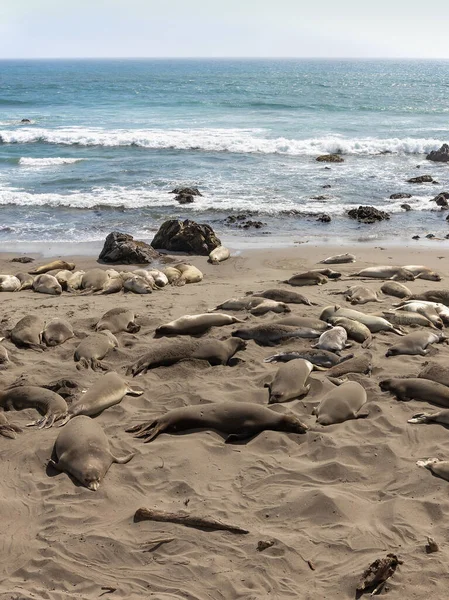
[0,59,449,247]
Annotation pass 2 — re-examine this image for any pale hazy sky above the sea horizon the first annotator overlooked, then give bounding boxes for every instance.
[0,0,449,58]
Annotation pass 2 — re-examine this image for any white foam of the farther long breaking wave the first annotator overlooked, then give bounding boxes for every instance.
[0,127,444,156]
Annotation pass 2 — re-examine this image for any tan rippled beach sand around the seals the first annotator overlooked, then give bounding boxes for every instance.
[0,246,449,600]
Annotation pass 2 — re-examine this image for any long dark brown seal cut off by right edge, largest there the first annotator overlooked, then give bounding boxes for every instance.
[379,377,449,408]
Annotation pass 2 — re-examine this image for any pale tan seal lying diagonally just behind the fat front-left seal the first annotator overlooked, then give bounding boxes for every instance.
[60,371,143,427]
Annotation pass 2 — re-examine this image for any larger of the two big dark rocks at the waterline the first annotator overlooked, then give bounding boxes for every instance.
[151,219,221,256]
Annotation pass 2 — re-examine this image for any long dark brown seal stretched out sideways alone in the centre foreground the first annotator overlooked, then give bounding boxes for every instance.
[126,402,307,443]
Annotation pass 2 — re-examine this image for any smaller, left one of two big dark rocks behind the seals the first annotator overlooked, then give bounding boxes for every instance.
[98,231,160,265]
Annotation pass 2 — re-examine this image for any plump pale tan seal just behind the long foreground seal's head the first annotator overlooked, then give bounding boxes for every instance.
[313,381,367,425]
